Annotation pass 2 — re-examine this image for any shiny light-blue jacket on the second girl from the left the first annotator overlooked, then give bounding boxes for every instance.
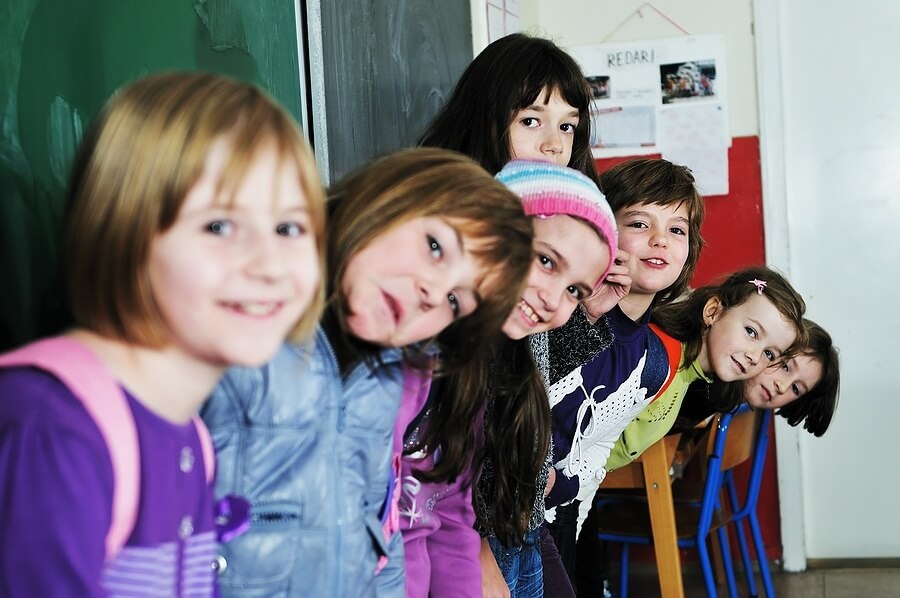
[201,327,404,597]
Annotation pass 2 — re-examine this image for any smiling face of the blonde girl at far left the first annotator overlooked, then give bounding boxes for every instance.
[147,139,320,367]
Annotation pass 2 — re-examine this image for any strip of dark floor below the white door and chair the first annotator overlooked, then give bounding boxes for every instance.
[596,563,900,598]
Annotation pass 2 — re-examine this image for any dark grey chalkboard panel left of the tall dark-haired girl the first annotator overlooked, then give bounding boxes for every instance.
[309,0,472,180]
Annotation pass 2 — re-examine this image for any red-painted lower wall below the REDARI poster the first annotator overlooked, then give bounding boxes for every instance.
[596,136,781,559]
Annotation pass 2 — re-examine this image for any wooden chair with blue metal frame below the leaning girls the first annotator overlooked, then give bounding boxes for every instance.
[594,406,771,598]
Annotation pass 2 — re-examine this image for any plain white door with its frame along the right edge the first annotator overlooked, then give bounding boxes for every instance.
[757,0,900,565]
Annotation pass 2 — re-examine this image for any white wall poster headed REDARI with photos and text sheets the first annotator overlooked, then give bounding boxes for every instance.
[569,34,731,194]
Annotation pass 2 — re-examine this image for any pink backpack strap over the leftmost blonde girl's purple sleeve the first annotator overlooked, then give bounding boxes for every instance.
[0,336,138,561]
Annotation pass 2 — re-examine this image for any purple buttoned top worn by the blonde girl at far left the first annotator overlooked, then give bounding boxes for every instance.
[0,368,216,596]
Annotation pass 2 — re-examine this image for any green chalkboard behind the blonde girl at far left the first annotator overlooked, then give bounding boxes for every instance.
[0,0,305,350]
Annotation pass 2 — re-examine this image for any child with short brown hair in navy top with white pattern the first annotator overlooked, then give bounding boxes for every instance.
[534,158,705,585]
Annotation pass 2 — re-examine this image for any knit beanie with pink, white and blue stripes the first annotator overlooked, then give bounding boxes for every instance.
[496,160,619,285]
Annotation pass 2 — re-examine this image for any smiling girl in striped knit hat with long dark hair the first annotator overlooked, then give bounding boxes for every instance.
[395,160,617,596]
